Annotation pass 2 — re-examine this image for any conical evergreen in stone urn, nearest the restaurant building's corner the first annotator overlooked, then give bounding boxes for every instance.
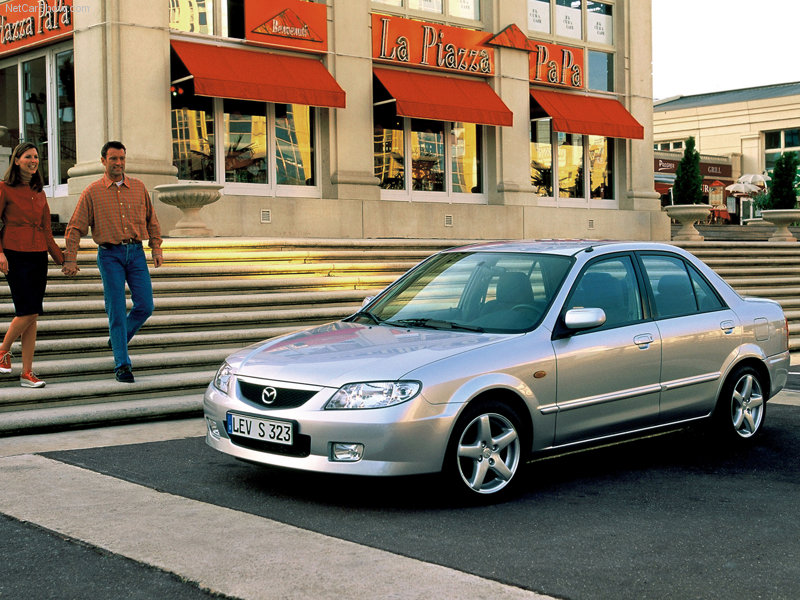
[665,137,711,241]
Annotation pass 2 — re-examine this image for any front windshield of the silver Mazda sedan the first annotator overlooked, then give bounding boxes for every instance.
[354,252,572,333]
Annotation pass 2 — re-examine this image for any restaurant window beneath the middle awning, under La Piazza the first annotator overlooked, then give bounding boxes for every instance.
[374,105,483,199]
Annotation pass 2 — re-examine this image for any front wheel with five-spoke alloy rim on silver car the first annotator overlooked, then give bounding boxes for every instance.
[443,401,530,500]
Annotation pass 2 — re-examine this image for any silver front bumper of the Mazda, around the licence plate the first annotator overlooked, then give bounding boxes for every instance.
[203,385,458,476]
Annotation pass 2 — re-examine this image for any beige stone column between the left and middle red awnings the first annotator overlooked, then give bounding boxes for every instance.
[322,0,380,200]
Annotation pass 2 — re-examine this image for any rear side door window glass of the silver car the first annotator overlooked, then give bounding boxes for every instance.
[642,255,708,319]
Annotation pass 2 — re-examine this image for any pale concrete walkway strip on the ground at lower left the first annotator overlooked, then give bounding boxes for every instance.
[0,419,549,600]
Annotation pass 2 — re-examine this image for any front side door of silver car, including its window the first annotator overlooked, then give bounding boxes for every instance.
[553,255,661,445]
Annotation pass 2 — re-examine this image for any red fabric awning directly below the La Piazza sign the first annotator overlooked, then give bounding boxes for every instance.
[373,68,514,126]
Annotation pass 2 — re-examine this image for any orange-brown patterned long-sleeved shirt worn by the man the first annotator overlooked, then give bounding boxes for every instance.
[64,174,161,261]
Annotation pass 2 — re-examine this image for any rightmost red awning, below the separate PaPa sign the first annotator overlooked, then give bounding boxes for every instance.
[531,89,644,140]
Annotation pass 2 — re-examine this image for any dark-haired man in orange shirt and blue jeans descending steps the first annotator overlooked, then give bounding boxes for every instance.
[62,141,163,383]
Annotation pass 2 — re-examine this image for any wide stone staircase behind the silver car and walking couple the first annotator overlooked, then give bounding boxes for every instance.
[0,238,800,435]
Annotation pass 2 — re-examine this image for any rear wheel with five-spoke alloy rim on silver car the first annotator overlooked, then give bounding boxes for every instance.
[712,366,767,444]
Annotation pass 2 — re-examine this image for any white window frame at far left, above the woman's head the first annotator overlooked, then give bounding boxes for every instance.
[0,40,77,198]
